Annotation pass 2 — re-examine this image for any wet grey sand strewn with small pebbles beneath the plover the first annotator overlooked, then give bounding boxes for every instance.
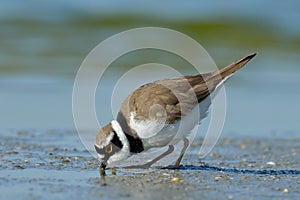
[0,130,300,199]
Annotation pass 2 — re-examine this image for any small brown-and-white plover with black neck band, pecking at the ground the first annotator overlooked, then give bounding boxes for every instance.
[94,53,256,169]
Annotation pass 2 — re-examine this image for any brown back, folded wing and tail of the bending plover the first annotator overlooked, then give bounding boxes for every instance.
[118,54,255,126]
